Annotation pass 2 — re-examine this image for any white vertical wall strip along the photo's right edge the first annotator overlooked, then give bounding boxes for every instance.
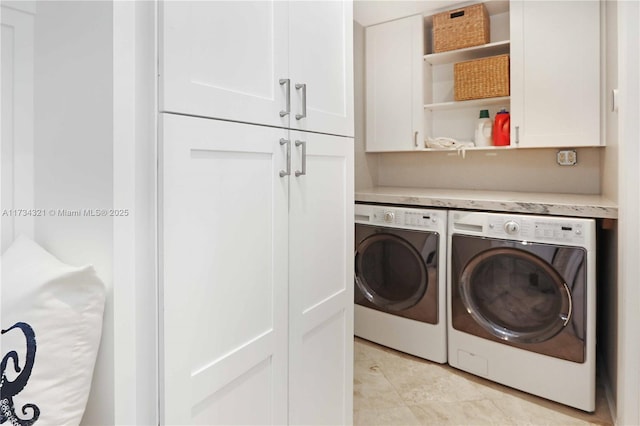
[616,1,640,425]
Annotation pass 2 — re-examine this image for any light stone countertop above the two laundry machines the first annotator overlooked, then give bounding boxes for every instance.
[355,186,618,219]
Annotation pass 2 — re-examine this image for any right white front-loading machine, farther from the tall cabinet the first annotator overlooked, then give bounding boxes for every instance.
[447,211,596,412]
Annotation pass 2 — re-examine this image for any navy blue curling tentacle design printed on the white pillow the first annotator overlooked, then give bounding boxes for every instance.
[0,322,40,426]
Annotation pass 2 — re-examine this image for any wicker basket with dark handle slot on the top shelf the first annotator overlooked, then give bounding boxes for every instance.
[433,3,489,53]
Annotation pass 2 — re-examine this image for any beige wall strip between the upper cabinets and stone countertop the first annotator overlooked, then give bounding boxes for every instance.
[378,148,600,194]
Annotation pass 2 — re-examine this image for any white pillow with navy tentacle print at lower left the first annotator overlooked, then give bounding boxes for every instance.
[0,236,105,426]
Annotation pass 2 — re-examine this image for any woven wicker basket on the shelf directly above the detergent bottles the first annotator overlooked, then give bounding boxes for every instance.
[453,55,509,101]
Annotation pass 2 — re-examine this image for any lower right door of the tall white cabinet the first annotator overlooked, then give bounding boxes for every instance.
[289,132,354,425]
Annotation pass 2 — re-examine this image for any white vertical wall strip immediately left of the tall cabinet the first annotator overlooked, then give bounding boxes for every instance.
[113,1,158,425]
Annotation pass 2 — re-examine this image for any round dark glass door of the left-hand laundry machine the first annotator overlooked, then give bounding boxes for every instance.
[355,233,429,312]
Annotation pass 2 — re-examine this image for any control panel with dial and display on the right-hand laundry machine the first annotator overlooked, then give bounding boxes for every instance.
[487,216,584,243]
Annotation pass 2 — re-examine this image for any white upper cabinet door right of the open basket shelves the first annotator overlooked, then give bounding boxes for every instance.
[510,0,601,147]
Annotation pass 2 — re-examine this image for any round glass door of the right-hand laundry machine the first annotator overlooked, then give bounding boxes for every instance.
[459,248,572,343]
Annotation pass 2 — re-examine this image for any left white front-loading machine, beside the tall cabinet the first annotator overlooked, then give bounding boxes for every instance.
[354,204,447,363]
